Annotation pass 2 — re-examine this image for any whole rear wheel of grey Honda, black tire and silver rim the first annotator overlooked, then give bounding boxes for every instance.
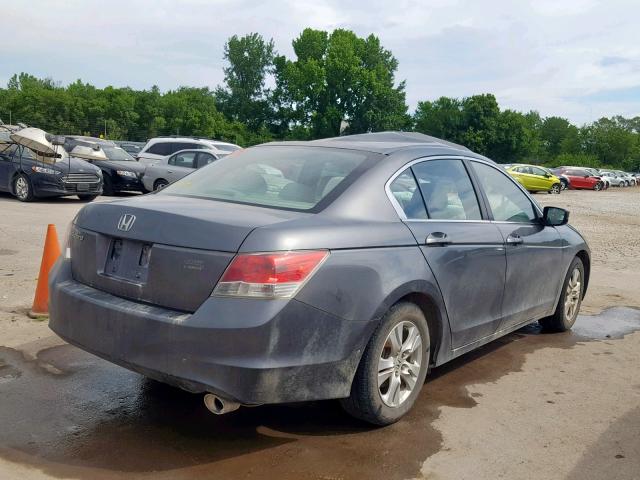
[341,302,430,425]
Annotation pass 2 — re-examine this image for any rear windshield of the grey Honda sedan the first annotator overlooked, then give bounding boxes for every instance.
[159,146,367,211]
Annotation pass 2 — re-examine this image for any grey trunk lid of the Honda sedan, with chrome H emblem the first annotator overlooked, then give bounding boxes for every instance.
[70,195,304,312]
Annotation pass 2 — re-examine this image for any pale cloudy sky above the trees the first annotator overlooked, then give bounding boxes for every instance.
[0,0,640,124]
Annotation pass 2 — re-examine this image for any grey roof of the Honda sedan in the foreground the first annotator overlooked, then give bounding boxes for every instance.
[265,132,484,158]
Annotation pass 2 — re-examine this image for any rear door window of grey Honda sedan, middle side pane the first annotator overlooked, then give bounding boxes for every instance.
[412,160,482,220]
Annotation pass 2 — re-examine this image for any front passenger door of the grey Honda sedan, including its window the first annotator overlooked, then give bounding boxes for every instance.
[471,161,565,328]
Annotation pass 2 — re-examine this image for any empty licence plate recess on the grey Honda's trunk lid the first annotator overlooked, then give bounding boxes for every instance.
[104,238,153,285]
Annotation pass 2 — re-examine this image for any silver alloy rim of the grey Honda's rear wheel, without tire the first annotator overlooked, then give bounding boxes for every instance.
[378,321,423,408]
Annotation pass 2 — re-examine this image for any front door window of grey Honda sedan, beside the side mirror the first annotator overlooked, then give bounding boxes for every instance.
[472,162,537,223]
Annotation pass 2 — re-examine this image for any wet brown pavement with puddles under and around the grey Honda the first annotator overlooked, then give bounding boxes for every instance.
[0,308,640,480]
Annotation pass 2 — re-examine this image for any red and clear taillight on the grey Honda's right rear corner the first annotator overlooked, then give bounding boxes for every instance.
[213,250,329,298]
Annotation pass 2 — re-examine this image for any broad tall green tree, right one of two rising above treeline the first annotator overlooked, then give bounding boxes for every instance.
[273,28,410,138]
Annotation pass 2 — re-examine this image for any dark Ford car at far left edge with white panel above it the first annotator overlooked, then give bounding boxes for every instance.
[0,143,102,202]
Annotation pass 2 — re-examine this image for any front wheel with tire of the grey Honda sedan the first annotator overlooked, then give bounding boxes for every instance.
[538,257,584,332]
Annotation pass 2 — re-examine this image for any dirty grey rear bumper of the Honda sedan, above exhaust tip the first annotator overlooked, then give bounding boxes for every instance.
[49,260,375,404]
